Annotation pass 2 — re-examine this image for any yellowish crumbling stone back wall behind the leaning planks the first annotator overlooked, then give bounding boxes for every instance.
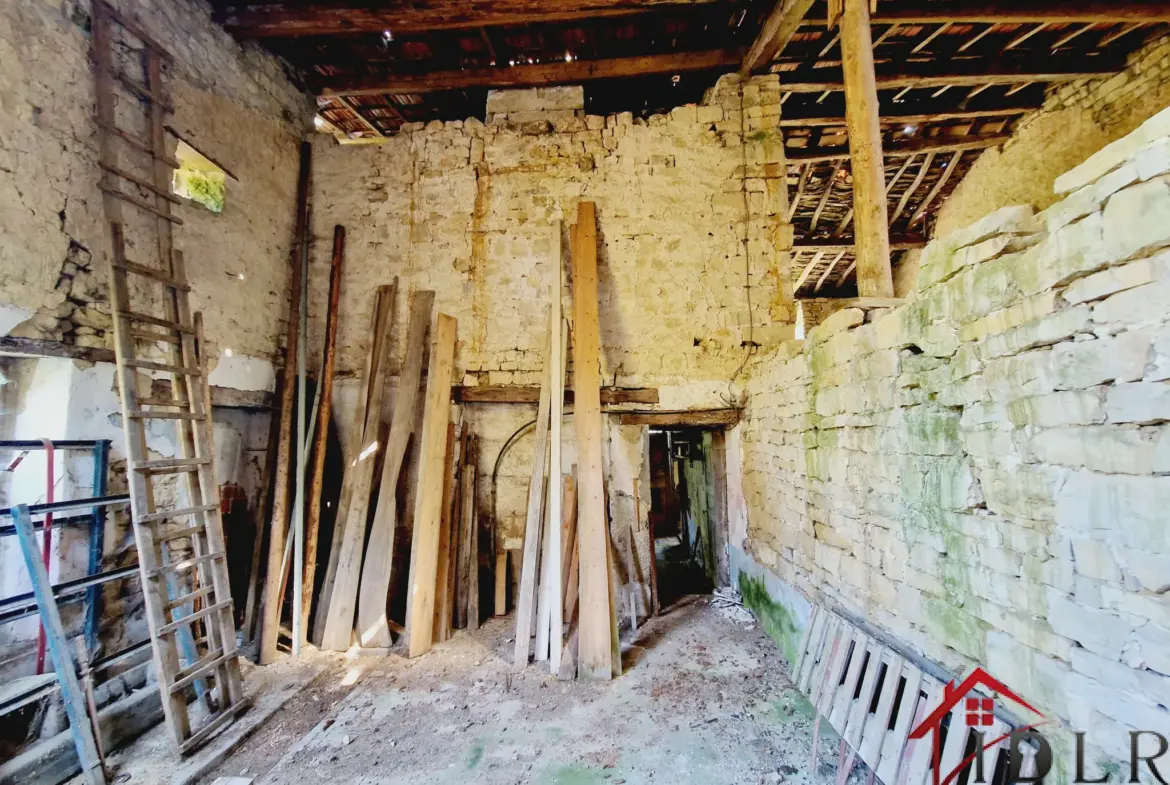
[310,76,793,559]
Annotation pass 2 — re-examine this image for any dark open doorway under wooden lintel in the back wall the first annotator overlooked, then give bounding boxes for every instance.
[648,427,728,610]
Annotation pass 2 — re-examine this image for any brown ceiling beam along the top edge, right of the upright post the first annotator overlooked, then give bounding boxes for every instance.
[805,0,1170,25]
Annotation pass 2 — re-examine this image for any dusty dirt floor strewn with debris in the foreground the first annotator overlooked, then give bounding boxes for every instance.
[202,597,859,785]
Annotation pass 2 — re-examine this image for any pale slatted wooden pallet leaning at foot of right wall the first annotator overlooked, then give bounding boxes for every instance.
[793,606,1026,785]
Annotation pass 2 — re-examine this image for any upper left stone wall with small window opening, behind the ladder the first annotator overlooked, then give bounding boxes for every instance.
[0,0,312,376]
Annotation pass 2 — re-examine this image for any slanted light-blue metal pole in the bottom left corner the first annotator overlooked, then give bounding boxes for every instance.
[13,504,106,785]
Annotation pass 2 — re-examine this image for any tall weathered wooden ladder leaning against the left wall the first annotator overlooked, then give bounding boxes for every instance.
[92,0,247,755]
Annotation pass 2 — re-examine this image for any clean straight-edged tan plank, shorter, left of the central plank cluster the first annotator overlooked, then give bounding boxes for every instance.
[407,314,456,657]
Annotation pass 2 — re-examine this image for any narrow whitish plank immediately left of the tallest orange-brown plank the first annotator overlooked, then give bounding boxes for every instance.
[542,251,569,674]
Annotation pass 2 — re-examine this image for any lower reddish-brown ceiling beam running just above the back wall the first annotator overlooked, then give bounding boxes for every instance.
[321,49,743,96]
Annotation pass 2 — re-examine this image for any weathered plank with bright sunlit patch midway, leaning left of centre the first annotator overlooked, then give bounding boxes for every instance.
[321,280,400,652]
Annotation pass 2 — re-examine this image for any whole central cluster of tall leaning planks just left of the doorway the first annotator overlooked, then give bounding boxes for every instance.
[512,202,621,679]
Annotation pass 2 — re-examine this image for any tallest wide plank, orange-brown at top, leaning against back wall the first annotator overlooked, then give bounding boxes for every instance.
[572,201,614,680]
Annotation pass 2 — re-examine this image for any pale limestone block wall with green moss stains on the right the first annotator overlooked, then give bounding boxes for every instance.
[743,104,1170,781]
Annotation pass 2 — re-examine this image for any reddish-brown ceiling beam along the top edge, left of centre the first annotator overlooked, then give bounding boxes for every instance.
[218,0,720,39]
